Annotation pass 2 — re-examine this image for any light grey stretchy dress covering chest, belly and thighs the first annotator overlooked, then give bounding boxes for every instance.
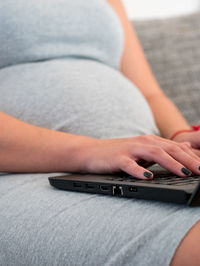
[0,0,200,266]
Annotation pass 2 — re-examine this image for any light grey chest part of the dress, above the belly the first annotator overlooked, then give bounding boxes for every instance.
[0,0,123,69]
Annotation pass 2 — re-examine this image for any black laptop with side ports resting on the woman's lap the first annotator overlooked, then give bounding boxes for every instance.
[49,164,200,206]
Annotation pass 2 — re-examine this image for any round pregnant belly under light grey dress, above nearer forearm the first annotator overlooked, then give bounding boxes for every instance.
[0,59,159,138]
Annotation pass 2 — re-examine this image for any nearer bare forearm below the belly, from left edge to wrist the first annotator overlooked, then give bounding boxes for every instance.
[0,113,97,172]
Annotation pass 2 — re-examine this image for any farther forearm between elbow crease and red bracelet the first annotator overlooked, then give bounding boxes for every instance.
[147,94,191,138]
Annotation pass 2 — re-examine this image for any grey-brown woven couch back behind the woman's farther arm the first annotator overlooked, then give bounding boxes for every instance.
[132,12,200,123]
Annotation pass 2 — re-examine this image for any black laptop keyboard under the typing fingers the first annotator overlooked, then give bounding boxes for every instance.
[104,170,200,186]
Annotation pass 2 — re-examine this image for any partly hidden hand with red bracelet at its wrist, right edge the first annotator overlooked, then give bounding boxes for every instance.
[173,130,200,157]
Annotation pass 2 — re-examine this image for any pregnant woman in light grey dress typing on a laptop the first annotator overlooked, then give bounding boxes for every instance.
[0,0,200,265]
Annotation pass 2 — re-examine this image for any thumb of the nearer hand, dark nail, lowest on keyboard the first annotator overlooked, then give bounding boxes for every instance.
[119,157,153,180]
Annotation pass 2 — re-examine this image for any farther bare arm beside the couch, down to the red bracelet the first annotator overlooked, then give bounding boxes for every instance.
[107,0,190,138]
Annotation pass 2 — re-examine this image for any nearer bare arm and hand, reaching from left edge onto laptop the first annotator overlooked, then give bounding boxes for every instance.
[0,109,199,179]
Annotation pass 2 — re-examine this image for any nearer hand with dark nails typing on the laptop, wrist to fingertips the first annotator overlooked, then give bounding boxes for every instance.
[76,135,200,180]
